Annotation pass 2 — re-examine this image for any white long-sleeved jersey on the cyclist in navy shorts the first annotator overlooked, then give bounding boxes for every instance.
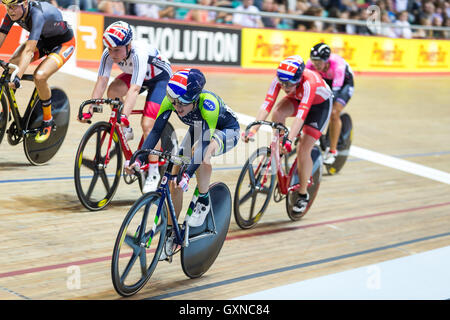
[98,41,172,86]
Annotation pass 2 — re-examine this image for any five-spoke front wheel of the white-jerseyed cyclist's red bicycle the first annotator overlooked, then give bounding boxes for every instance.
[74,122,123,211]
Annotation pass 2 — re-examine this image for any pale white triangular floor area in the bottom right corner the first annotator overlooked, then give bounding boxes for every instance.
[234,247,450,300]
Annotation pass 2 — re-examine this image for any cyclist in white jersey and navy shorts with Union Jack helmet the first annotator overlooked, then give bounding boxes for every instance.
[81,21,172,193]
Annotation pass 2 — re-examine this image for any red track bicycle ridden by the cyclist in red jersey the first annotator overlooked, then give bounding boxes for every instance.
[233,121,323,229]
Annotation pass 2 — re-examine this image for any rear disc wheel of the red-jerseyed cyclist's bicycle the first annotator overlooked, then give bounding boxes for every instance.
[286,146,323,221]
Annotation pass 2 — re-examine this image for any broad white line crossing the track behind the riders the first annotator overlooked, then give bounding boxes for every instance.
[61,66,450,184]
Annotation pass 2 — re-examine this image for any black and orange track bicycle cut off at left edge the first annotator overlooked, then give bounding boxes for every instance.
[0,60,70,165]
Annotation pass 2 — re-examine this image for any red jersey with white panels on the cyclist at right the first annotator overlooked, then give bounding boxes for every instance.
[261,69,332,117]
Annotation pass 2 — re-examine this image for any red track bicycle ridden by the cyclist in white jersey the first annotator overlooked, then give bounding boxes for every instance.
[74,99,178,211]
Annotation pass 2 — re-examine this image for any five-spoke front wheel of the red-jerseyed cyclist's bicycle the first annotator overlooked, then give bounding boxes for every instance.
[233,147,275,229]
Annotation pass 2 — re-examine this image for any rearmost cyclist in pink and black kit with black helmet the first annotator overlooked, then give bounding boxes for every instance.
[306,42,354,164]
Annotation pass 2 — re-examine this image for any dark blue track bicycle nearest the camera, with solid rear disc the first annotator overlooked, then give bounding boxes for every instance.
[111,149,231,297]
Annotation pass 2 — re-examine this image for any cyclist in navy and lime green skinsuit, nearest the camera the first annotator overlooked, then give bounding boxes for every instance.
[127,69,239,240]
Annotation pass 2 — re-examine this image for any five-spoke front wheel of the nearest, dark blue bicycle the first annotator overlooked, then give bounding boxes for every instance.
[111,192,167,297]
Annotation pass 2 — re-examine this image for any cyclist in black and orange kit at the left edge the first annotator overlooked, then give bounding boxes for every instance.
[0,0,75,143]
